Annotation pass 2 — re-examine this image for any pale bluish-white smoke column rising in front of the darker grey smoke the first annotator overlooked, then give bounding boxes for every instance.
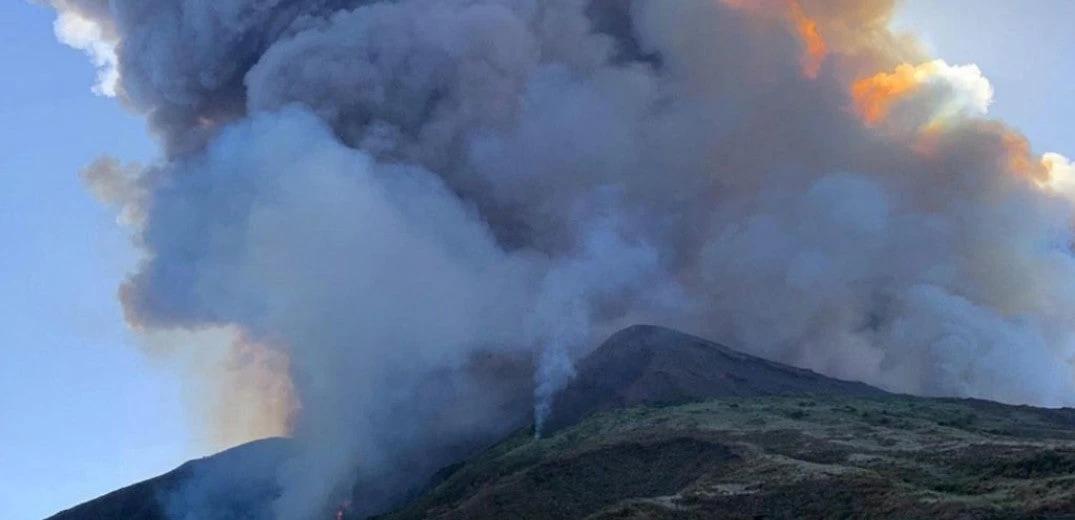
[147,111,537,518]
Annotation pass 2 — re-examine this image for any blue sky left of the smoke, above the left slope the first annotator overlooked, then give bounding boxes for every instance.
[0,0,192,520]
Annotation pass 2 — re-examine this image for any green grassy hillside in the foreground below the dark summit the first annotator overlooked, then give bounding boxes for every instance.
[385,396,1075,520]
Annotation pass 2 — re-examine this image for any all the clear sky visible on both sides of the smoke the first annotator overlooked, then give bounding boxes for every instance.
[0,0,1075,520]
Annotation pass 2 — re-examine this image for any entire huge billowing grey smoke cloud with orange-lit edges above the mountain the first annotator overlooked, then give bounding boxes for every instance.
[51,0,1075,520]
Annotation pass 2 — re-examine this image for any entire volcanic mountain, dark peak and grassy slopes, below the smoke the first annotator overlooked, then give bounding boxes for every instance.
[39,326,1075,520]
